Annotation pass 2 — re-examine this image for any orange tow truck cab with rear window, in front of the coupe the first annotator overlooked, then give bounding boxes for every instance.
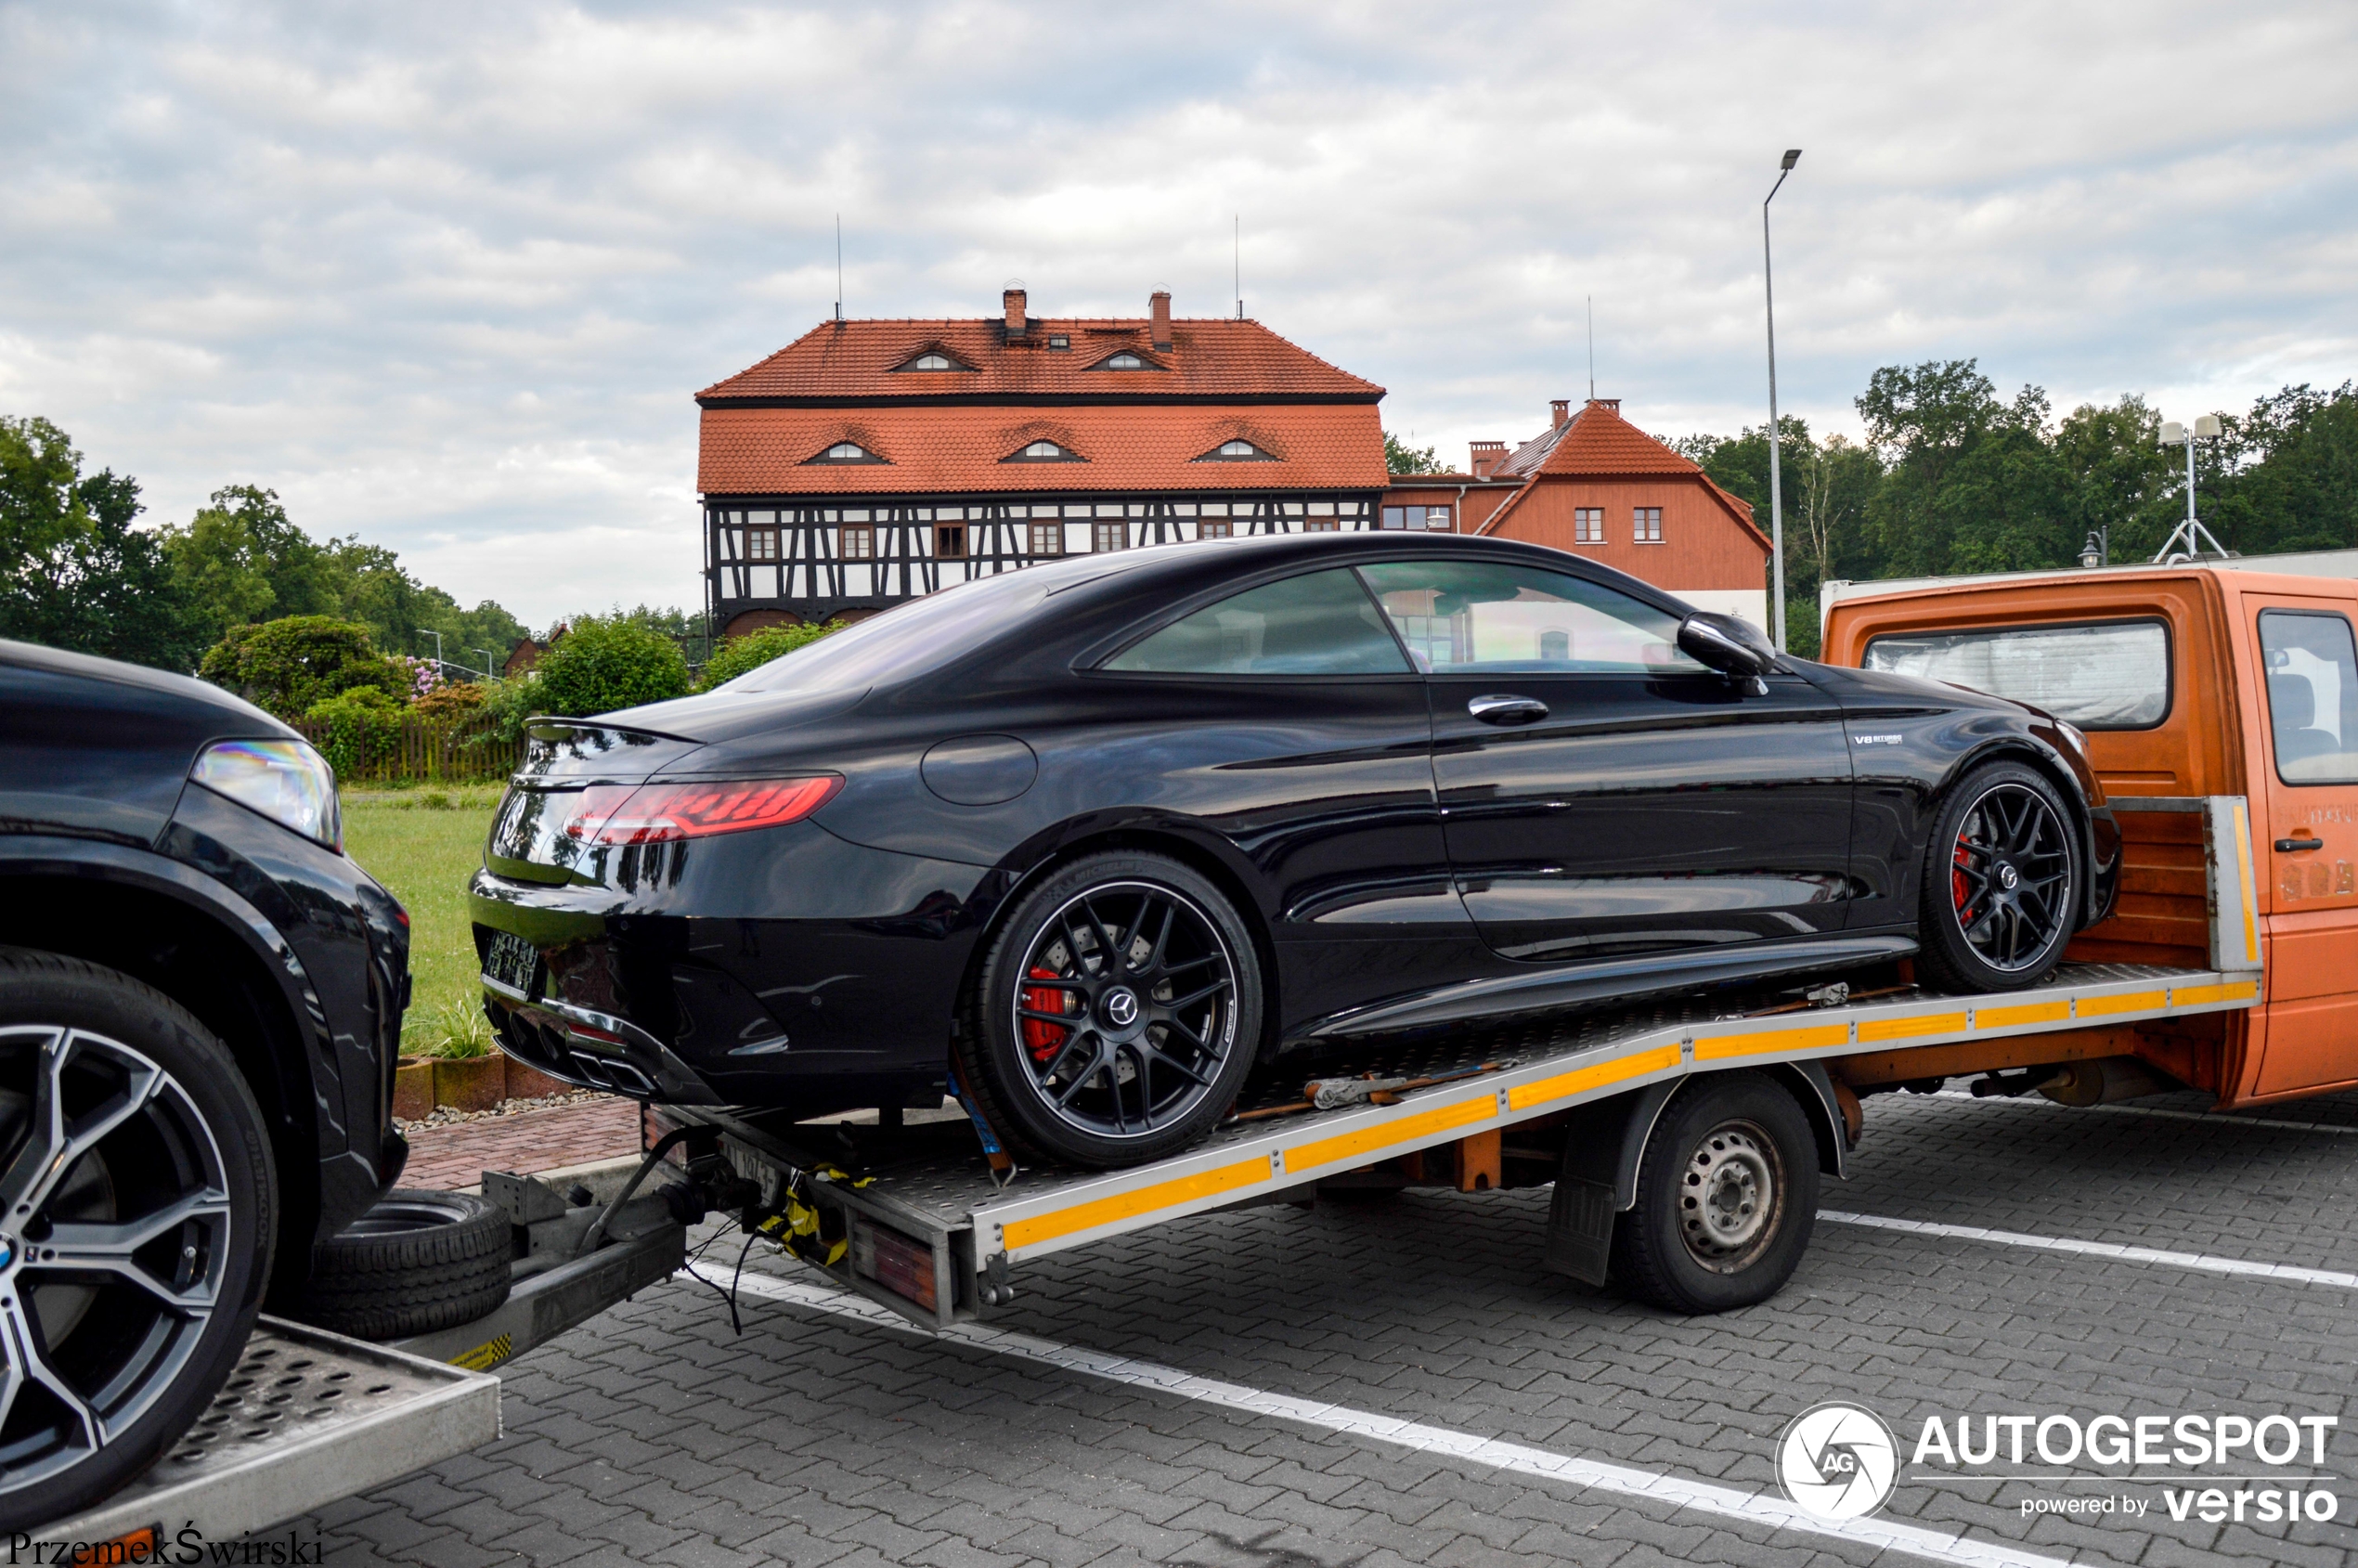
[1822,566,2358,1108]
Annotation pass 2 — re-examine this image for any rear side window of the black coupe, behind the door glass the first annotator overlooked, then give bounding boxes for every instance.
[1104,571,1407,674]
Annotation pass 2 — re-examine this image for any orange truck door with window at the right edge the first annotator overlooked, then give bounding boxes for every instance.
[2245,594,2358,1094]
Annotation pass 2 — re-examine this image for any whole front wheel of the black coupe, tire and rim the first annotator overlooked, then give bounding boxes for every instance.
[1917,761,2082,992]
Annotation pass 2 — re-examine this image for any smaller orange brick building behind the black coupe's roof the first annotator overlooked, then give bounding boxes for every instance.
[1381,398,1768,629]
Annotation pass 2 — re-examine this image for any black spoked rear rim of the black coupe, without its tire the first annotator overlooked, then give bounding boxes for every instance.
[1009,882,1238,1139]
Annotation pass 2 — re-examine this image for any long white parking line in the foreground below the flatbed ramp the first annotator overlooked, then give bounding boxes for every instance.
[691,1263,2066,1568]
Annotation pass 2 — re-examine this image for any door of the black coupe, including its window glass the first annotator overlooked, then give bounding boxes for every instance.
[1363,559,1851,965]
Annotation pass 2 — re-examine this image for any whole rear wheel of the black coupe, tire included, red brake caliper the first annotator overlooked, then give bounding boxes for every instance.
[957,851,1262,1170]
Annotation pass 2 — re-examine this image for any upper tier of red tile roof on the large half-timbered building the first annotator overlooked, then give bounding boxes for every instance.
[695,316,1384,408]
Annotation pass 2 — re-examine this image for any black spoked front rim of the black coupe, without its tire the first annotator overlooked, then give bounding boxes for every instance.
[1948,783,2073,974]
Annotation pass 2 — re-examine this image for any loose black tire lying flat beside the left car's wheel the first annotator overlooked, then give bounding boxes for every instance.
[302,1188,510,1340]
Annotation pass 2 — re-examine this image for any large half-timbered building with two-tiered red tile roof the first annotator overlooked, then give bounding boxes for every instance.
[695,288,1384,637]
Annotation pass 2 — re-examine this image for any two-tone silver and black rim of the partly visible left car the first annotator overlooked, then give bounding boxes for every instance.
[0,1026,231,1490]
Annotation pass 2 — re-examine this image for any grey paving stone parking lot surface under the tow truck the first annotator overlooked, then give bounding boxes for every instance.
[294,1096,2358,1568]
